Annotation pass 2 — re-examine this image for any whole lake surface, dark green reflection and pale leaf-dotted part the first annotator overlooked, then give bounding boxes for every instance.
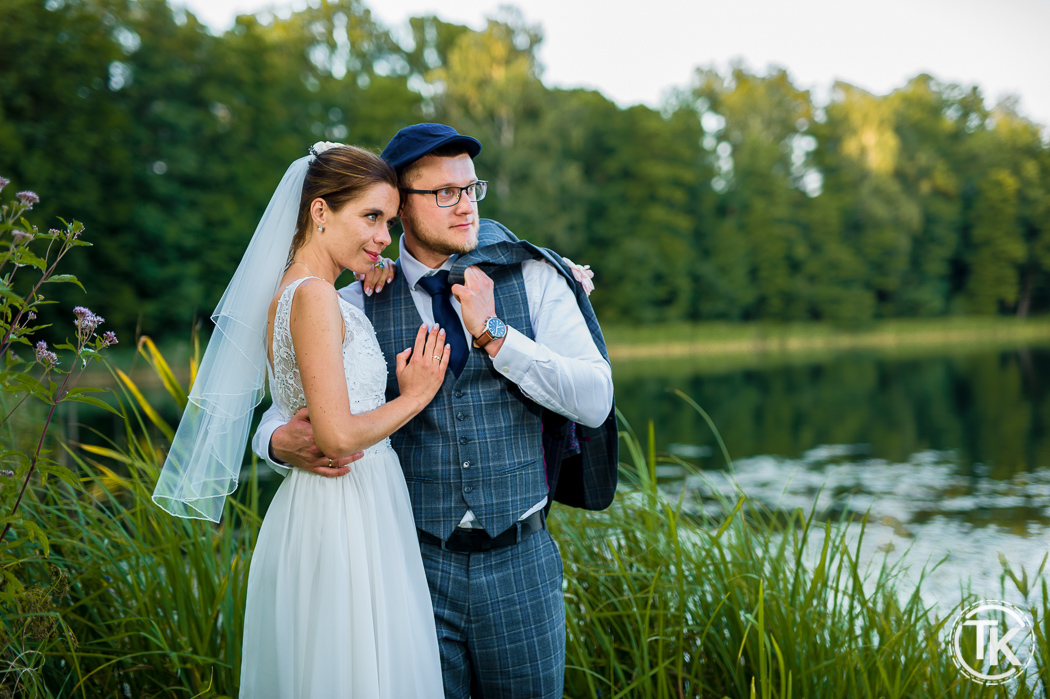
[614,348,1050,608]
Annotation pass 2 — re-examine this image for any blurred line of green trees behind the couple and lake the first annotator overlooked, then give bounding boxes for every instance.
[0,0,1050,338]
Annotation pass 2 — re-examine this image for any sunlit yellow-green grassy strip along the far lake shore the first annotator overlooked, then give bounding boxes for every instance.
[603,316,1050,366]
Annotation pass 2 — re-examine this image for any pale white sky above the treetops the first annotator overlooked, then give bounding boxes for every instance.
[173,0,1050,129]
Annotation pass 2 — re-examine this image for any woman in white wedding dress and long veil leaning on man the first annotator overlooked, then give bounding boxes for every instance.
[153,144,449,699]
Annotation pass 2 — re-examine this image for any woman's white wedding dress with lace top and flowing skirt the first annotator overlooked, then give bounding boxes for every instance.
[240,279,443,699]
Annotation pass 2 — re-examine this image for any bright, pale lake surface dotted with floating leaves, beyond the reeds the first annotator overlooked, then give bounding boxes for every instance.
[667,445,1050,610]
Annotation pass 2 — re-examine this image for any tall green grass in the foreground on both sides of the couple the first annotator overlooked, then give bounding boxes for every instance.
[0,340,1050,699]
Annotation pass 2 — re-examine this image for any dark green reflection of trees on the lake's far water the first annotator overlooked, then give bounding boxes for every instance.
[614,348,1050,480]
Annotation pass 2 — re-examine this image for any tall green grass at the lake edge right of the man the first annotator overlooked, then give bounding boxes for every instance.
[551,413,1050,699]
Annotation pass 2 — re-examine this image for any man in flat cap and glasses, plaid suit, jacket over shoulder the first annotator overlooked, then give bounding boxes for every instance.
[253,124,617,699]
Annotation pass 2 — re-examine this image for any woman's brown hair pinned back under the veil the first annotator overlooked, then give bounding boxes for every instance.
[288,145,397,261]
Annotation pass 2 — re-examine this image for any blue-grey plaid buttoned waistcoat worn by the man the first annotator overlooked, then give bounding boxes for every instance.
[364,234,547,538]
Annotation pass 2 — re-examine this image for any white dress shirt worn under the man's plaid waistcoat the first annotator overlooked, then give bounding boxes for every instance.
[252,236,612,522]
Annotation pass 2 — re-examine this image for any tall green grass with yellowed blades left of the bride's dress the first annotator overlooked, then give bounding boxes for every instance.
[0,335,253,697]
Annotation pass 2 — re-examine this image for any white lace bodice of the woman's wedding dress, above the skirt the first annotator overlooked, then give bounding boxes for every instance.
[269,277,386,420]
